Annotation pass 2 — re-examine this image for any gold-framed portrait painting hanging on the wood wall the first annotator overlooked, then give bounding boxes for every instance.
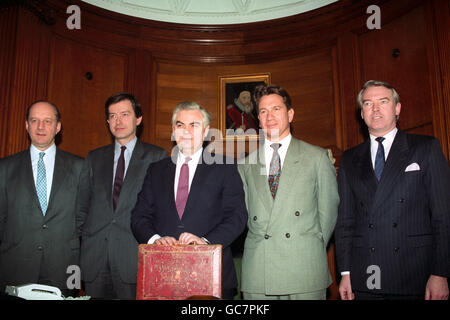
[218,72,271,140]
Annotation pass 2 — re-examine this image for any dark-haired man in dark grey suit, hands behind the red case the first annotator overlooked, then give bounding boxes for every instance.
[81,93,167,299]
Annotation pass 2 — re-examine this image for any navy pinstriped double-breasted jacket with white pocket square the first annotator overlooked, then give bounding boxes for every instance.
[335,130,450,294]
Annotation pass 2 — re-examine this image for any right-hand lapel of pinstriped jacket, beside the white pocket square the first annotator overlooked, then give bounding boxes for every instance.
[373,130,409,210]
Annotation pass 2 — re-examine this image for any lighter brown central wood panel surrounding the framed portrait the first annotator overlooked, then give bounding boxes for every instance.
[156,52,338,152]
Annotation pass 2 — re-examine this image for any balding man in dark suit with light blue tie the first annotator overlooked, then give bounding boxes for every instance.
[0,100,88,295]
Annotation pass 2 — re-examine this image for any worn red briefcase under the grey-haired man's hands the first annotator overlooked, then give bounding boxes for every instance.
[136,244,222,300]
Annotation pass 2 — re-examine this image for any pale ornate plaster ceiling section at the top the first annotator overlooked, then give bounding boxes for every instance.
[82,0,337,25]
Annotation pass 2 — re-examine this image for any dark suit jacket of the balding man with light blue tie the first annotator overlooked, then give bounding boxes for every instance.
[0,148,88,290]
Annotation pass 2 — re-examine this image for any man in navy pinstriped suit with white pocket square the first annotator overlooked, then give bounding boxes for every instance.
[335,80,450,299]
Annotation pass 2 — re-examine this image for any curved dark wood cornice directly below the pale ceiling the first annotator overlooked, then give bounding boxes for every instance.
[38,0,423,64]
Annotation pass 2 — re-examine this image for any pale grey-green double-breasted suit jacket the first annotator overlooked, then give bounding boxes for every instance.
[238,137,339,295]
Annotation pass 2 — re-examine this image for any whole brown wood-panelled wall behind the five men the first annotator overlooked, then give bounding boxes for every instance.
[0,0,450,158]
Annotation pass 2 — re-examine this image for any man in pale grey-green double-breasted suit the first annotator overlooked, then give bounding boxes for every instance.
[238,85,339,300]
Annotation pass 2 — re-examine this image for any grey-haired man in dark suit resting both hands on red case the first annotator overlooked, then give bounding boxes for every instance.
[131,102,247,299]
